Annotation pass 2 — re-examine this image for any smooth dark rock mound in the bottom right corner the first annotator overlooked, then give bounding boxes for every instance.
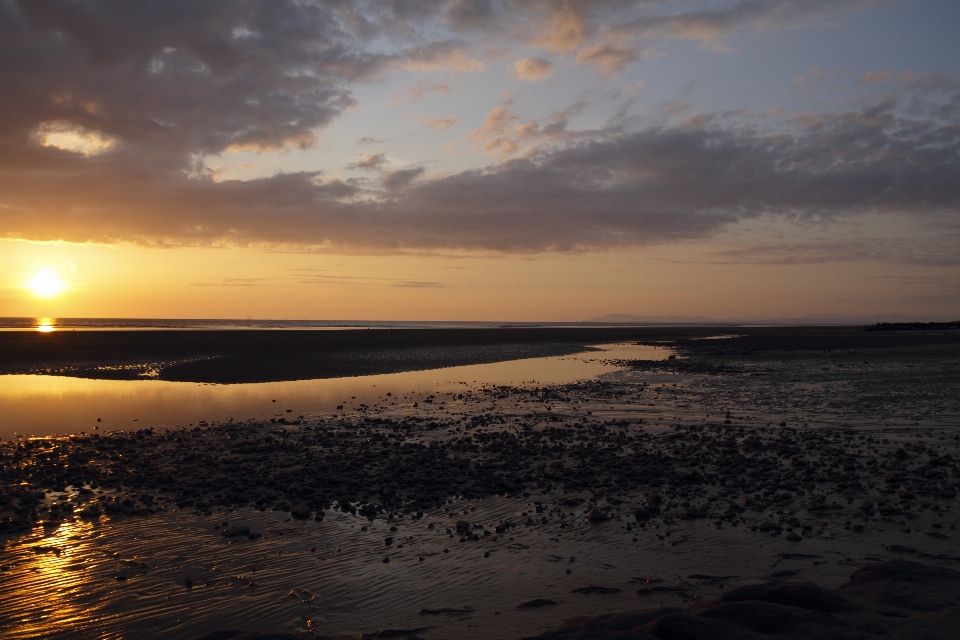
[537,560,960,640]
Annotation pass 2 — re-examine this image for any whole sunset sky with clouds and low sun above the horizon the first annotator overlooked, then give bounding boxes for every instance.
[0,0,960,321]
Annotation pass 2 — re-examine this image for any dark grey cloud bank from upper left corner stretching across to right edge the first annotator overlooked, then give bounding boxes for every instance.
[0,0,960,252]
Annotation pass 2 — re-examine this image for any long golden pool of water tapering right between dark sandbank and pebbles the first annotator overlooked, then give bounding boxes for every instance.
[0,344,669,439]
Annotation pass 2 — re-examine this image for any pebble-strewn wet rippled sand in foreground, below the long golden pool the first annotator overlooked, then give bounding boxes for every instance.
[0,333,960,638]
